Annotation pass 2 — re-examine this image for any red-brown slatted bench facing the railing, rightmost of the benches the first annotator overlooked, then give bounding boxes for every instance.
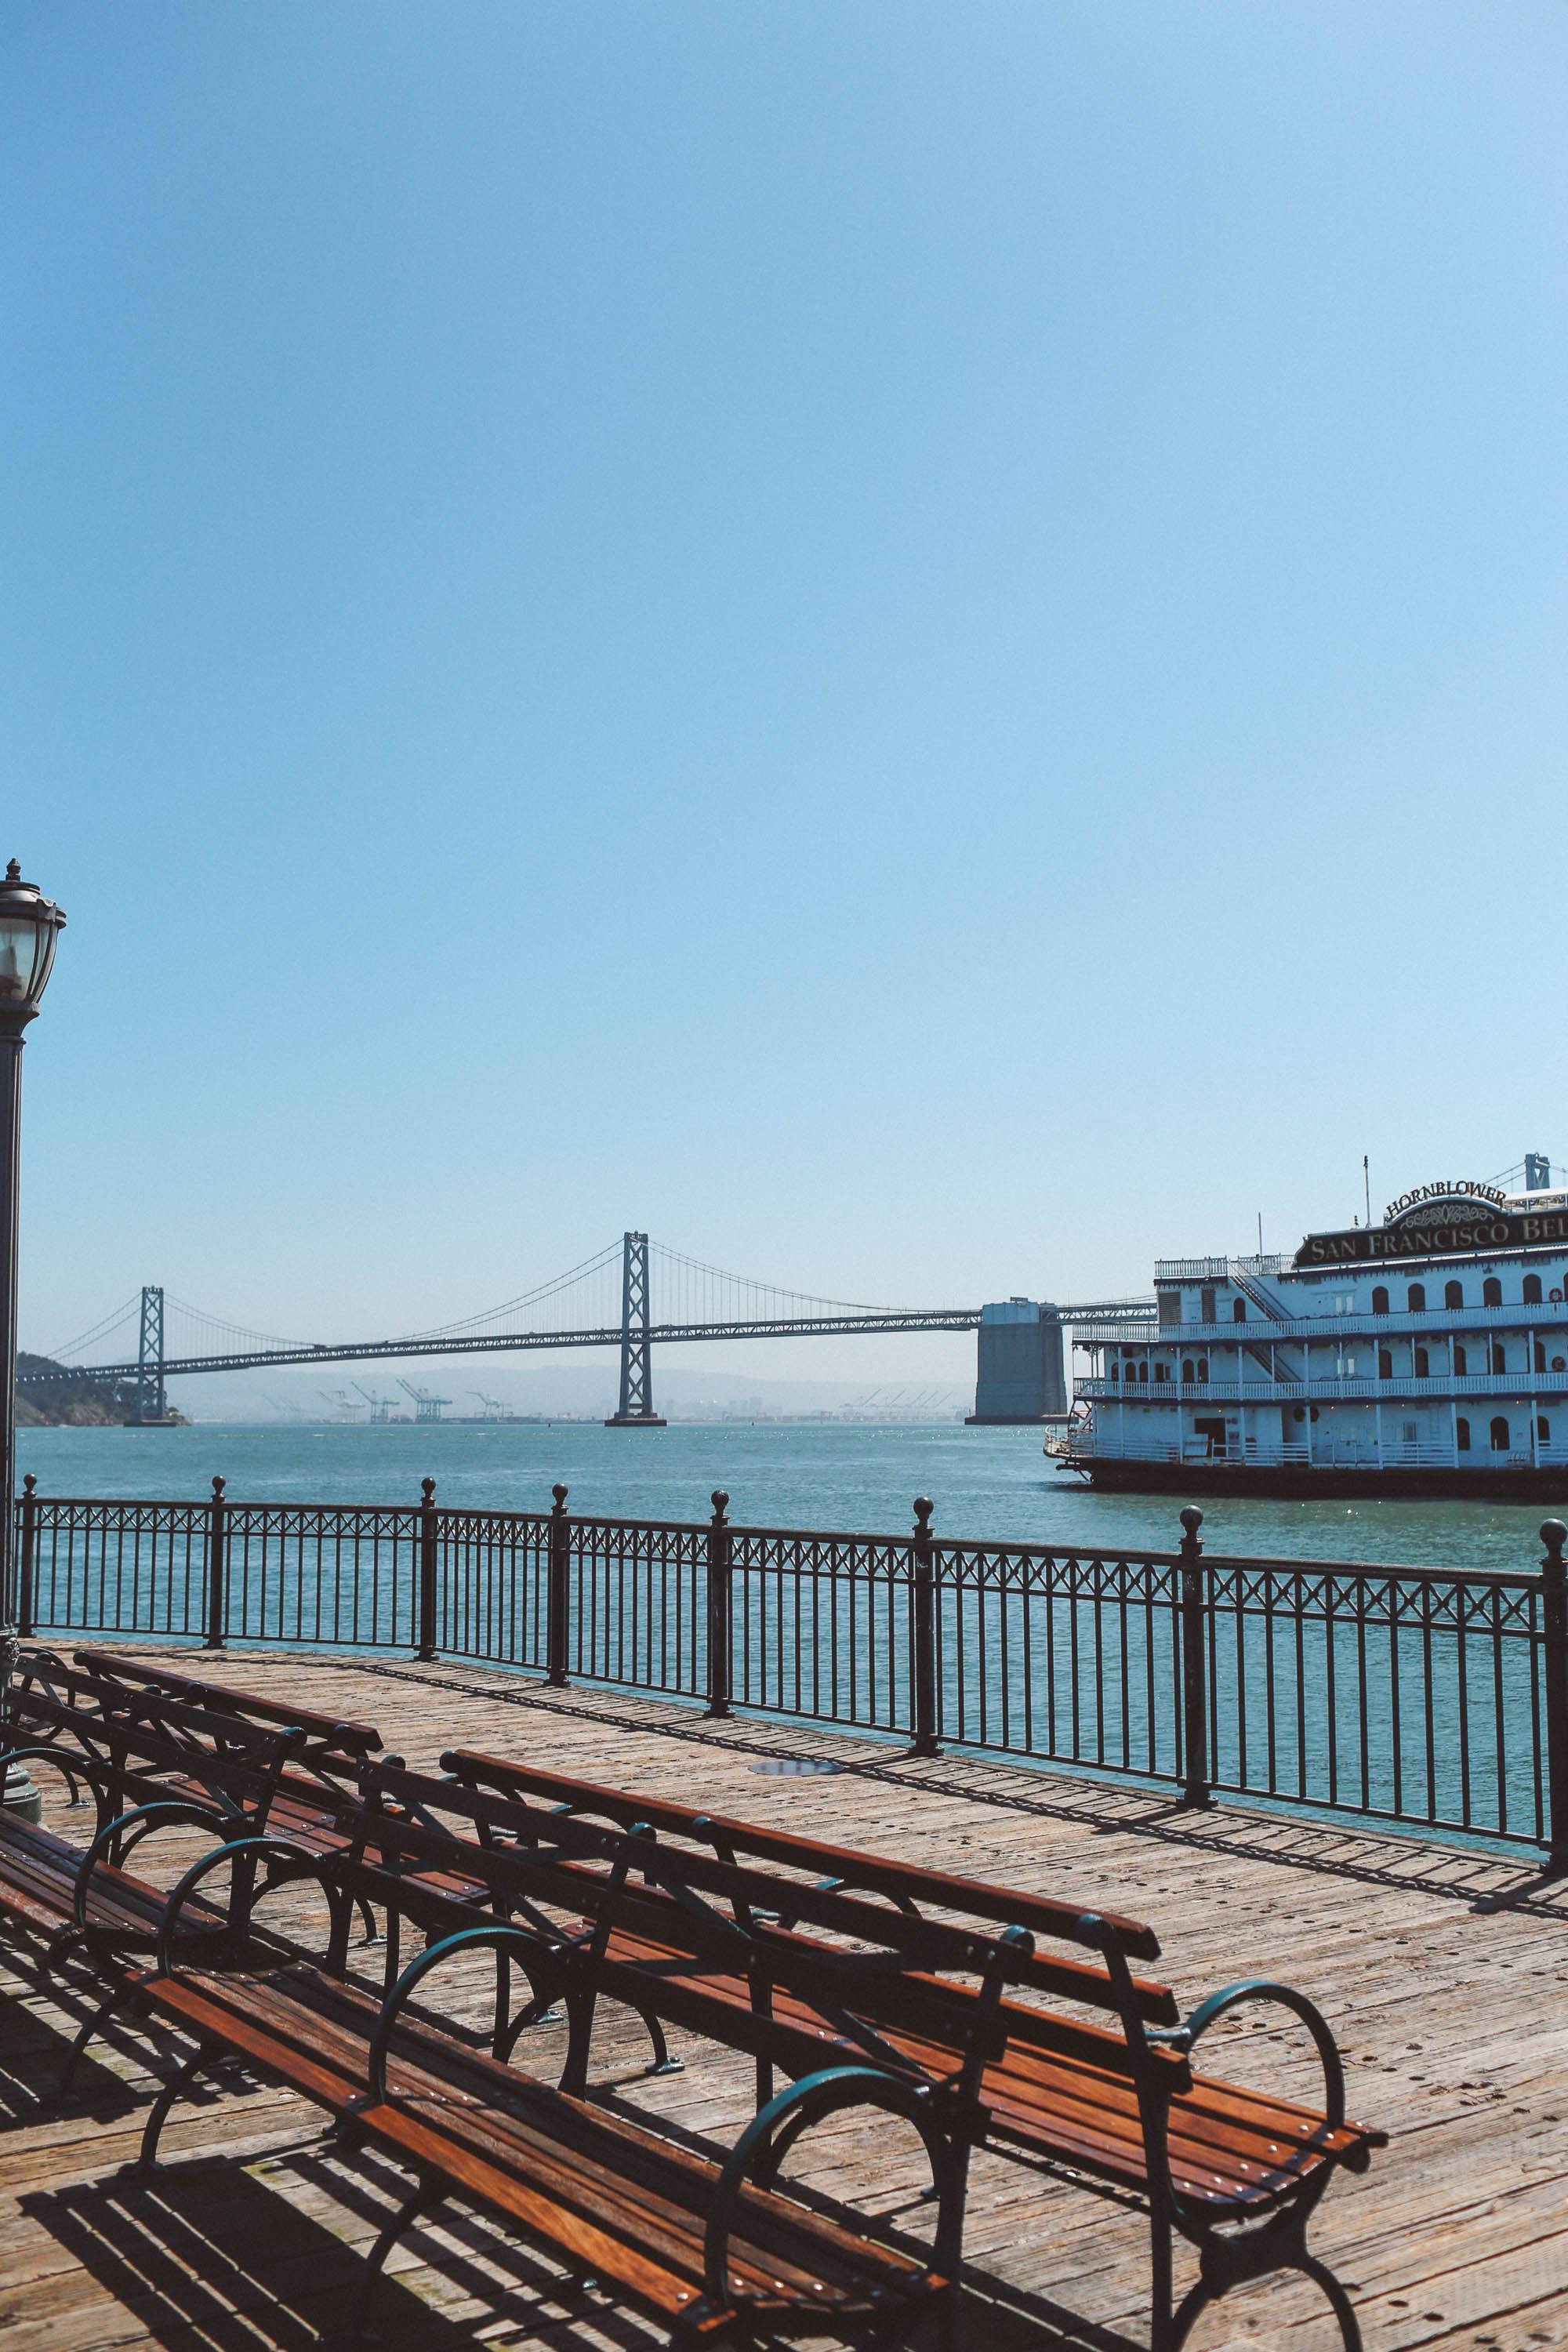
[442,1750,1387,2352]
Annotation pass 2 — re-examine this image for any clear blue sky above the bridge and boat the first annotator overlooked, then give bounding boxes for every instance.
[0,0,1568,1374]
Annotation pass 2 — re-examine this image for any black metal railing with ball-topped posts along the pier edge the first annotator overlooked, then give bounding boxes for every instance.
[16,1479,1568,1863]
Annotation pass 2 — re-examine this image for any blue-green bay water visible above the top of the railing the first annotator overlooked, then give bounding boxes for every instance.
[16,1423,1544,1571]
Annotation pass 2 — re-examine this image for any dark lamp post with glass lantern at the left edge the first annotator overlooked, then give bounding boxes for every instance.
[0,858,66,1820]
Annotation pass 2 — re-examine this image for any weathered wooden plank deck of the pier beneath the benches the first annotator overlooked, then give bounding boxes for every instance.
[0,1653,1568,2352]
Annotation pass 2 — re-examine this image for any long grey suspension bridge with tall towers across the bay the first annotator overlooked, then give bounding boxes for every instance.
[16,1232,1154,1428]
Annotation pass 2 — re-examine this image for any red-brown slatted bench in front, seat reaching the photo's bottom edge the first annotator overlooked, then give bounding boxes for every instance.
[119,1806,968,2345]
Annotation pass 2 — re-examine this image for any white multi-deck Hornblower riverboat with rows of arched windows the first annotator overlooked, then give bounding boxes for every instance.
[1062,1155,1568,1503]
